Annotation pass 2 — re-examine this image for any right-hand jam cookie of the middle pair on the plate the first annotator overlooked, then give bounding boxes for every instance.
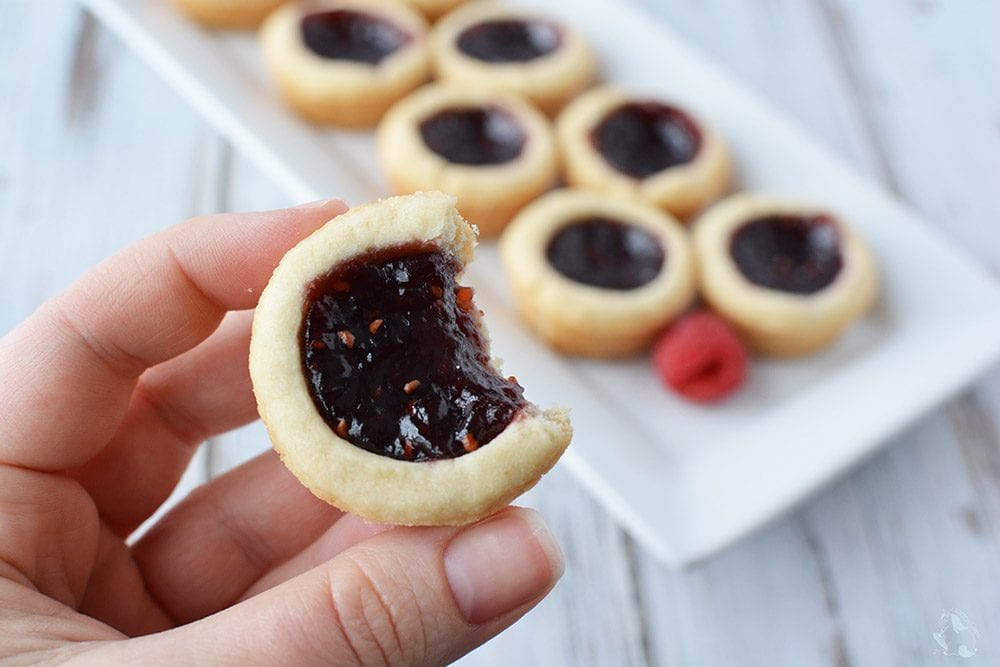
[556,87,731,218]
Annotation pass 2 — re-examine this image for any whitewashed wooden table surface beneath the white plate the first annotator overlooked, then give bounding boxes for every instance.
[0,0,1000,667]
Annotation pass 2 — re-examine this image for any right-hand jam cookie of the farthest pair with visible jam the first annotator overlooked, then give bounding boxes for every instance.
[431,1,596,115]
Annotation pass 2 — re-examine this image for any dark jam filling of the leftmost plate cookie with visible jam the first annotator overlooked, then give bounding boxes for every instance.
[302,9,412,65]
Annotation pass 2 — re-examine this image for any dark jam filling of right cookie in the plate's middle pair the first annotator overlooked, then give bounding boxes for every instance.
[591,102,701,178]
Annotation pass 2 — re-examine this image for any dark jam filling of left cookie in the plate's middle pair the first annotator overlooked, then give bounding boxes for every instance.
[420,105,527,166]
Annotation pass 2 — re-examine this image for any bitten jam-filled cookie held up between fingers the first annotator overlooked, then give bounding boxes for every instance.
[250,193,571,525]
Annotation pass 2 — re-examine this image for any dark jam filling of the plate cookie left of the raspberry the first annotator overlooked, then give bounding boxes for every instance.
[546,217,666,290]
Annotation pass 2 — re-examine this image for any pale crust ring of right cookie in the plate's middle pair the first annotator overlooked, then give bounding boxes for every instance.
[556,86,732,219]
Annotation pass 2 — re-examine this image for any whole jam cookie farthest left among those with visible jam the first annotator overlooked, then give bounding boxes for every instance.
[260,0,430,127]
